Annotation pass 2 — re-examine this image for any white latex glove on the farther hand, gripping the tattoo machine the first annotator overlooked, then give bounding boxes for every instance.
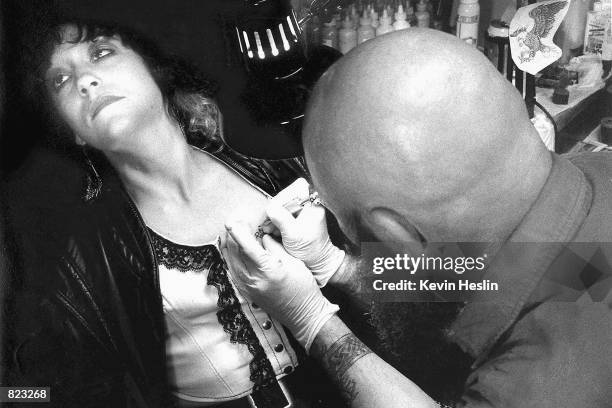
[266,186,345,287]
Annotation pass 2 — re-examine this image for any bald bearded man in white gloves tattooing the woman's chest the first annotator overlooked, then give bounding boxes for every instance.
[228,29,612,408]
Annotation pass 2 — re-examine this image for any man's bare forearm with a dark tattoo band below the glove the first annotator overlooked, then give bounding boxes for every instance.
[310,316,438,408]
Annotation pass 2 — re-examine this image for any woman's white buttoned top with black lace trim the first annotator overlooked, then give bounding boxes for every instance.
[150,230,298,405]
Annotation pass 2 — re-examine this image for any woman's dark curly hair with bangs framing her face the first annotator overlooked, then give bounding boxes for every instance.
[30,21,223,150]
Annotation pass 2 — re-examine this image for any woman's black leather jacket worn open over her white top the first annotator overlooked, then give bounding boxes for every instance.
[3,147,305,407]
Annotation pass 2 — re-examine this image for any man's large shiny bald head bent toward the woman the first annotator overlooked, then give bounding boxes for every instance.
[303,29,550,245]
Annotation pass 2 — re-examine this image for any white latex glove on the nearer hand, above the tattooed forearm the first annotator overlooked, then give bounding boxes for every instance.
[226,221,339,352]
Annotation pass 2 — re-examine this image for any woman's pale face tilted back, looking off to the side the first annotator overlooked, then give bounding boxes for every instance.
[45,26,166,151]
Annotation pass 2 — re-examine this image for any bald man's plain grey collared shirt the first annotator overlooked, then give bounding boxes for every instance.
[451,153,612,408]
